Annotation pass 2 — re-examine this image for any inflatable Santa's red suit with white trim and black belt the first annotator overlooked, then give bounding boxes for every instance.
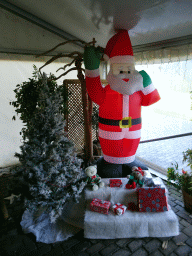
[86,30,160,164]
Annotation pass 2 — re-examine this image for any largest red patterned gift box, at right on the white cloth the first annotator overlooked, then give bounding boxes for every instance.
[137,187,168,212]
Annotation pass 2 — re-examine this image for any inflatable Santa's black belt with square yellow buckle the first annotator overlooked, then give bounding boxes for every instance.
[99,116,141,128]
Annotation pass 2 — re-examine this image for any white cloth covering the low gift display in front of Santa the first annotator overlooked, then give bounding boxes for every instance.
[84,173,179,239]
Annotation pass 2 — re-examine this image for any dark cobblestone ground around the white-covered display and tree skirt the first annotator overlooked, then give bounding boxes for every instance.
[0,176,192,256]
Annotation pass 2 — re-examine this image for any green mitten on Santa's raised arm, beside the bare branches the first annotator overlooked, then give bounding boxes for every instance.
[84,46,102,70]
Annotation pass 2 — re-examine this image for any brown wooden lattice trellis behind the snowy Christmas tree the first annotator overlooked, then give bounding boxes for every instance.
[64,79,107,152]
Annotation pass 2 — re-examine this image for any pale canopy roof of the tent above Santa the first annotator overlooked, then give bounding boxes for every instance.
[0,0,192,54]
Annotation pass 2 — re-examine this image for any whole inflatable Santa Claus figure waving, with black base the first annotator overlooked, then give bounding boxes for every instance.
[84,30,160,178]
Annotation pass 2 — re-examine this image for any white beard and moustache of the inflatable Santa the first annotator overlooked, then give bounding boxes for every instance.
[107,70,144,95]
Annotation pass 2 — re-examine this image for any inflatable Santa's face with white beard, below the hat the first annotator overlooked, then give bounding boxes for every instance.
[107,63,143,95]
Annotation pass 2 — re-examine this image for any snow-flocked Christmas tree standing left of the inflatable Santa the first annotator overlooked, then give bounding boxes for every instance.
[12,73,86,223]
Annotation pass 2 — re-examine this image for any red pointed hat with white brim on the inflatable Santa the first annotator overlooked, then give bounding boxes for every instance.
[104,29,134,64]
